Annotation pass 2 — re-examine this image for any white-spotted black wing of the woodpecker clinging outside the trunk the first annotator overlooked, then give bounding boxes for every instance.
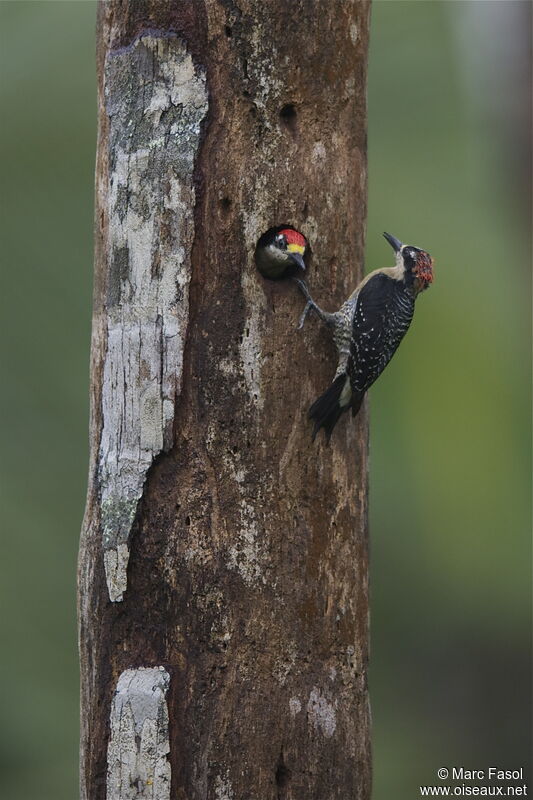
[348,273,415,392]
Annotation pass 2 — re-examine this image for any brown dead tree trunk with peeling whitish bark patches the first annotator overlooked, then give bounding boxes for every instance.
[79,0,370,800]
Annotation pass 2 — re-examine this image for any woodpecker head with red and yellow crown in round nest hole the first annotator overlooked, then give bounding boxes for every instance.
[254,225,308,280]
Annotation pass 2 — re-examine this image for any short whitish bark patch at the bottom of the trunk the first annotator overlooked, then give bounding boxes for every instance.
[106,667,171,800]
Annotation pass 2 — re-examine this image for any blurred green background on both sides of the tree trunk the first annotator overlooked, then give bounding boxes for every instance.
[0,0,531,800]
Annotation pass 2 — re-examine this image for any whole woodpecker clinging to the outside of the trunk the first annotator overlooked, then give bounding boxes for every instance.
[295,233,433,442]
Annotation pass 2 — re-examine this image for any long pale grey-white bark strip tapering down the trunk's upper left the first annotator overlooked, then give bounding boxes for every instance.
[98,33,207,602]
